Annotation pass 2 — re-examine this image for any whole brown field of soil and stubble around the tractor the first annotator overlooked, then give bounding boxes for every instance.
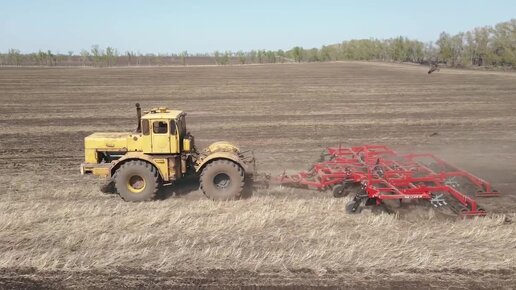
[0,62,516,289]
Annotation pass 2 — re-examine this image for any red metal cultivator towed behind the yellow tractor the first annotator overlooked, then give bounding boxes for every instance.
[272,145,499,216]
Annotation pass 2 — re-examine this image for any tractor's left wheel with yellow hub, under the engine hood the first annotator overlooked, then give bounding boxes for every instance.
[113,160,159,201]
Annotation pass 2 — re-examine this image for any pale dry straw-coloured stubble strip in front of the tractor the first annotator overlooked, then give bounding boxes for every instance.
[0,179,516,273]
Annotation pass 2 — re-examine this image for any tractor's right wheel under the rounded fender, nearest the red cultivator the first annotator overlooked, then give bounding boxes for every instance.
[200,159,244,200]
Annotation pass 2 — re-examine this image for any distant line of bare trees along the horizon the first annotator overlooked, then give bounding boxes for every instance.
[0,19,516,68]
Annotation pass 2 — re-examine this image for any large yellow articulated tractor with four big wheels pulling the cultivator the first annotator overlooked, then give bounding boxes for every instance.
[81,104,255,201]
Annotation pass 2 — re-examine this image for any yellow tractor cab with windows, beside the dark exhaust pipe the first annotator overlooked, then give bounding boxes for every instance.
[137,107,193,154]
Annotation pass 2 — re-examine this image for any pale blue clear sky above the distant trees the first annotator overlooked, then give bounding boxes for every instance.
[0,0,516,54]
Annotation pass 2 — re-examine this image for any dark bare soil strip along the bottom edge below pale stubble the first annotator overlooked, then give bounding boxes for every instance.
[0,269,516,289]
